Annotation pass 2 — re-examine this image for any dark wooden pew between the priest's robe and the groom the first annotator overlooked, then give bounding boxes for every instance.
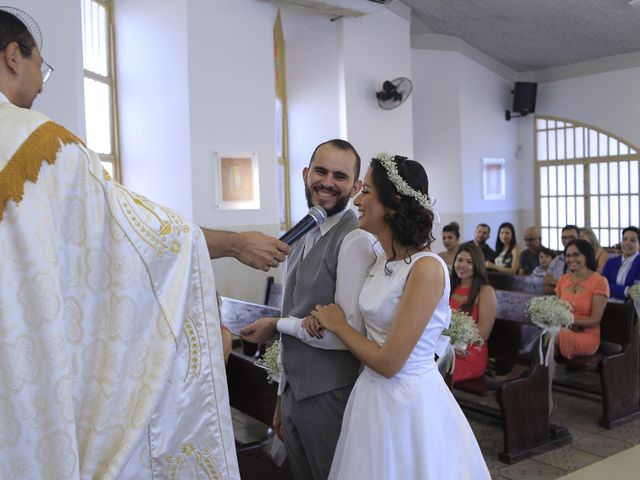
[220,297,293,480]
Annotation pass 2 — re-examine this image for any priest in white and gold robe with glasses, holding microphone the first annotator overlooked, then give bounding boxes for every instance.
[0,6,246,479]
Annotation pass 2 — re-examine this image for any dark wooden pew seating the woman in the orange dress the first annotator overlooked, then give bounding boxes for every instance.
[554,302,640,428]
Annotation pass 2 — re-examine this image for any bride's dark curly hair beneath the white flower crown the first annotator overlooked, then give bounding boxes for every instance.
[371,155,435,253]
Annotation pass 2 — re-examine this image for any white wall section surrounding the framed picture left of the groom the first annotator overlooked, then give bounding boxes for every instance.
[188,0,278,228]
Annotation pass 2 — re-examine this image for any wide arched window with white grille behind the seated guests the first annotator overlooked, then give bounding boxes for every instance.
[534,116,640,249]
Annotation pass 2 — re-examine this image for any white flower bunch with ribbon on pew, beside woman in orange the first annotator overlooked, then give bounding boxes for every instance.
[527,295,573,367]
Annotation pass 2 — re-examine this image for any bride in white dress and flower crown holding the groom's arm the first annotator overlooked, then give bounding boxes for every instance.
[311,154,490,480]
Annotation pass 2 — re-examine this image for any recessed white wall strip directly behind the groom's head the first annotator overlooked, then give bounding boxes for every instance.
[281,8,340,222]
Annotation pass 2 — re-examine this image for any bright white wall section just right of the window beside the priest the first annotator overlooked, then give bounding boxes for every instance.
[114,0,193,218]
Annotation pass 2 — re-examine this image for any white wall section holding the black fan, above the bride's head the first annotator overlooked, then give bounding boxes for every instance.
[338,9,414,163]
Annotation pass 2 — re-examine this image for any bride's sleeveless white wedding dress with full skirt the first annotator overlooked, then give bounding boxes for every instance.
[329,252,490,480]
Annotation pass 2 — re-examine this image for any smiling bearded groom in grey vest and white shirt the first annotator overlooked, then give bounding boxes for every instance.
[242,139,374,480]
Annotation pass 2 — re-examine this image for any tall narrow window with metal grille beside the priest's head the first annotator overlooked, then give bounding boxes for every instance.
[82,0,120,181]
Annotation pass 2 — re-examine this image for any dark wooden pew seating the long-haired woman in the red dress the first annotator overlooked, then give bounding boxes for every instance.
[453,291,571,463]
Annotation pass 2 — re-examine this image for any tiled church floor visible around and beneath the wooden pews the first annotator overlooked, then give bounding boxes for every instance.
[232,371,640,480]
